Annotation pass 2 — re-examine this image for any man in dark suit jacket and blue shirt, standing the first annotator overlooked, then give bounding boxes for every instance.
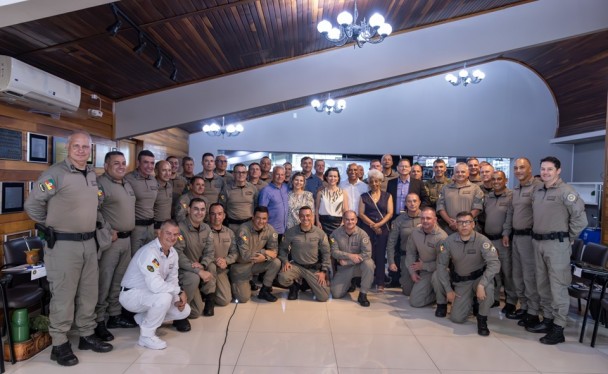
[386,158,430,287]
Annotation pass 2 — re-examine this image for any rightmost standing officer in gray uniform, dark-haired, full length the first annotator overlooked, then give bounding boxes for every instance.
[526,156,587,344]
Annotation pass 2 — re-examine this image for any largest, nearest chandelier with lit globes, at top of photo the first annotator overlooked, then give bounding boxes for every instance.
[317,0,393,48]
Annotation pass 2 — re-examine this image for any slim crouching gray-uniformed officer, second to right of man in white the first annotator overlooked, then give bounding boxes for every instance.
[209,203,238,306]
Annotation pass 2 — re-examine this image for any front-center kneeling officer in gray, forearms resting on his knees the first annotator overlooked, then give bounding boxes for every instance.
[278,206,331,301]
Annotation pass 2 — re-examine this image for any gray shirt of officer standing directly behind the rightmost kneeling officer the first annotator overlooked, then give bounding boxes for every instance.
[437,181,483,218]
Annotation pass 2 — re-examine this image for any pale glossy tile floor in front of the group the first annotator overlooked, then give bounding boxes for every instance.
[7,289,608,374]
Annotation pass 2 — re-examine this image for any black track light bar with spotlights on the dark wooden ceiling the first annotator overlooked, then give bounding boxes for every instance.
[107,3,177,82]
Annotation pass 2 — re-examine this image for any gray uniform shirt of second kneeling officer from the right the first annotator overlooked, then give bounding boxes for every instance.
[405,225,448,273]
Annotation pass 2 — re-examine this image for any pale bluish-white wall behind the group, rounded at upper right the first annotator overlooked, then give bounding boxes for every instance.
[190,61,573,180]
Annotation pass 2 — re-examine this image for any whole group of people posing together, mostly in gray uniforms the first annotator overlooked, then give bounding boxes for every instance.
[26,132,587,366]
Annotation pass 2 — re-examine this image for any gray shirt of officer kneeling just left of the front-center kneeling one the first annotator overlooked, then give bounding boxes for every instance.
[237,221,279,264]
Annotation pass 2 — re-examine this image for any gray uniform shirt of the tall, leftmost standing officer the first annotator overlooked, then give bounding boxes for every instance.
[25,158,100,233]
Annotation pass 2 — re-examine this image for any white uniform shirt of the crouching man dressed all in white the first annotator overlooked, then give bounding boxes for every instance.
[120,238,180,296]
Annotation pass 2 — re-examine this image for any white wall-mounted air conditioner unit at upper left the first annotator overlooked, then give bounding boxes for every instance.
[0,55,80,113]
